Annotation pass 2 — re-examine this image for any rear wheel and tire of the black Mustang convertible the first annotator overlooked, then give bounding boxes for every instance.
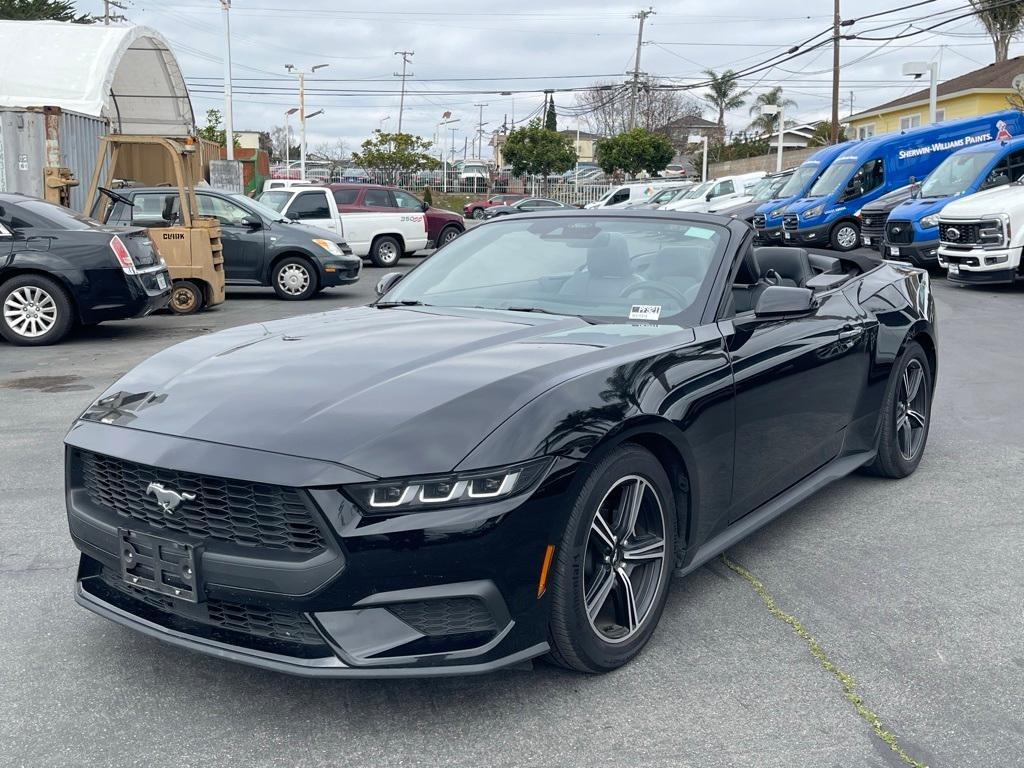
[864,341,933,478]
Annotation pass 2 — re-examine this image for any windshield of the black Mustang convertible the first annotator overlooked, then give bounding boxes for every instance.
[380,215,728,324]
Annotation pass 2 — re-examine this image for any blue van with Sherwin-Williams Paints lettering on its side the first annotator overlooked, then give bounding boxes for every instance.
[782,110,1024,251]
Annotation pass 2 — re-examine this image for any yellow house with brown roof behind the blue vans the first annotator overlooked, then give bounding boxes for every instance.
[846,56,1024,138]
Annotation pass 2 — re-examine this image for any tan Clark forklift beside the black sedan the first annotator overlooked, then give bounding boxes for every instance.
[83,135,224,314]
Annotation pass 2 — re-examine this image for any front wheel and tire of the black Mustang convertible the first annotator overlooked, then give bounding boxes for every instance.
[548,443,676,674]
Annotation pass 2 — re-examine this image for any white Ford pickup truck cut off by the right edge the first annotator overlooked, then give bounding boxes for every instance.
[938,181,1024,285]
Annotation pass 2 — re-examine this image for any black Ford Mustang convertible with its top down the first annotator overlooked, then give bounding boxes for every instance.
[67,211,937,677]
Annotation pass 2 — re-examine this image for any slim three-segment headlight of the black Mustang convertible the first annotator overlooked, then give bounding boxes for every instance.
[342,458,551,514]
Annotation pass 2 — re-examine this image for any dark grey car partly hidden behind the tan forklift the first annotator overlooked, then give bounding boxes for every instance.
[106,186,362,301]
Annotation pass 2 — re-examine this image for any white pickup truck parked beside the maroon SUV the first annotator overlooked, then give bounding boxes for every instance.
[258,186,427,266]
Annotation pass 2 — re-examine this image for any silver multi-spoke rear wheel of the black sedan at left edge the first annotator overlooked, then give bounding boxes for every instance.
[0,274,74,347]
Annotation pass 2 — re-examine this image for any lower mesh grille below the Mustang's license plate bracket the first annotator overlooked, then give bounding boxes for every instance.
[98,567,324,645]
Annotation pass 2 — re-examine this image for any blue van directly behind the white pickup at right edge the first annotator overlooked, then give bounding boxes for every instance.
[882,137,1024,266]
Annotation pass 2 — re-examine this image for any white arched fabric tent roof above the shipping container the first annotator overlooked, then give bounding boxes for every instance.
[0,22,196,136]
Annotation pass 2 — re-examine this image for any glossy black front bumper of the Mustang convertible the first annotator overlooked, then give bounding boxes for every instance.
[68,423,574,677]
